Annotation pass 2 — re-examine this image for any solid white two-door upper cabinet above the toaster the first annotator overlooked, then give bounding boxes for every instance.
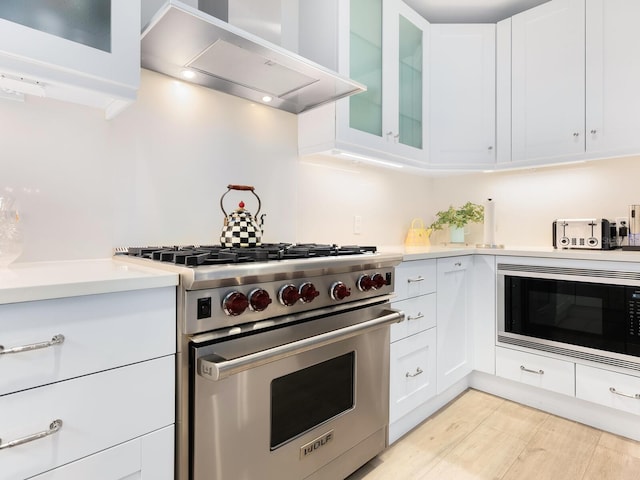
[497,0,640,166]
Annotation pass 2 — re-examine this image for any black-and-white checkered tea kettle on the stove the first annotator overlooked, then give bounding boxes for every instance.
[220,185,265,247]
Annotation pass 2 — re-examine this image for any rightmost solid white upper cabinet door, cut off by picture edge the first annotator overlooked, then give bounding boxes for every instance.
[586,0,640,154]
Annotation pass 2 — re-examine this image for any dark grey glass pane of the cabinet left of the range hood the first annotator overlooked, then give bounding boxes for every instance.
[0,0,111,52]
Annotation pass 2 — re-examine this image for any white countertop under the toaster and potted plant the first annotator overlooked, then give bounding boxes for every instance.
[380,245,640,262]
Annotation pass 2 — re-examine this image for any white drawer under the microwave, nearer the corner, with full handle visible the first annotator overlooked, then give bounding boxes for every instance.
[496,347,575,396]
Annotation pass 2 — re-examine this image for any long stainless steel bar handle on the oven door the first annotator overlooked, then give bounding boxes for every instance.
[198,310,404,381]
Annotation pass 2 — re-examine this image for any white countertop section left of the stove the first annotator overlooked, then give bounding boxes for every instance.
[0,258,178,304]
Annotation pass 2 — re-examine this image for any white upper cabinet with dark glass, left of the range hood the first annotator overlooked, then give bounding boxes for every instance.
[0,0,140,118]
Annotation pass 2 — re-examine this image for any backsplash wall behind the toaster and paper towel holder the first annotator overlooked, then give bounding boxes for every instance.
[430,157,640,247]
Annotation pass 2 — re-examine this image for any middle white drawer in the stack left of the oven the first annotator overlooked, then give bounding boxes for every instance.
[0,355,175,479]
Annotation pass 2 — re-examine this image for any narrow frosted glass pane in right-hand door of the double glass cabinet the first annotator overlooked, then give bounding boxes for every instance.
[398,15,424,148]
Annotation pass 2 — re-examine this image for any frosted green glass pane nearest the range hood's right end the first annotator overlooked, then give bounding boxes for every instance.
[349,0,382,137]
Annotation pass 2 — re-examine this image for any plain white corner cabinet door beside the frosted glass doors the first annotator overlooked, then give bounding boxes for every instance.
[429,24,496,167]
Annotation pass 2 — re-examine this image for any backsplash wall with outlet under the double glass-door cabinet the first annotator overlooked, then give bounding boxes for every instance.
[297,156,432,246]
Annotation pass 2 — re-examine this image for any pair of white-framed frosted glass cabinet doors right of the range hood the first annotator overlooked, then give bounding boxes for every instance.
[338,0,429,164]
